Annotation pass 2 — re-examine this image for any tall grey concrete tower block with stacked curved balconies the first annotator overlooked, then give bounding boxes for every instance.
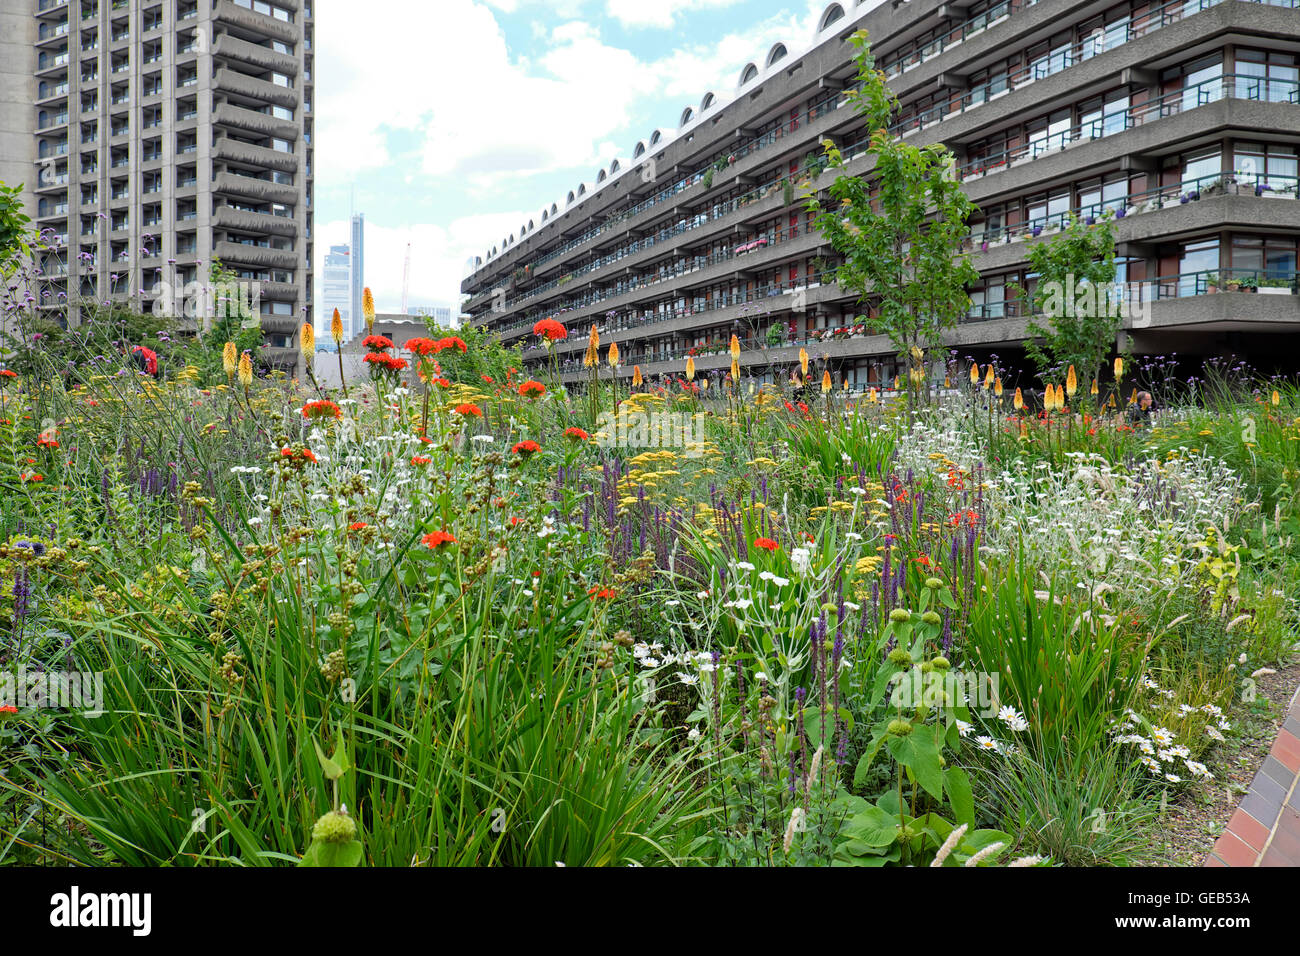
[0,0,313,367]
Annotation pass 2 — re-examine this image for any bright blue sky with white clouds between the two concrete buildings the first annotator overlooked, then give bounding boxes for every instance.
[315,0,847,321]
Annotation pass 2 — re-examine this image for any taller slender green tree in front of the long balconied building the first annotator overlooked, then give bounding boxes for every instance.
[807,30,979,395]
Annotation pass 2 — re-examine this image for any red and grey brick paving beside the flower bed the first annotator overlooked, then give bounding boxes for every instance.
[1205,688,1300,866]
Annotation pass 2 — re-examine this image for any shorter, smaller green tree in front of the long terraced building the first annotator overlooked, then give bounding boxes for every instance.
[1014,212,1122,382]
